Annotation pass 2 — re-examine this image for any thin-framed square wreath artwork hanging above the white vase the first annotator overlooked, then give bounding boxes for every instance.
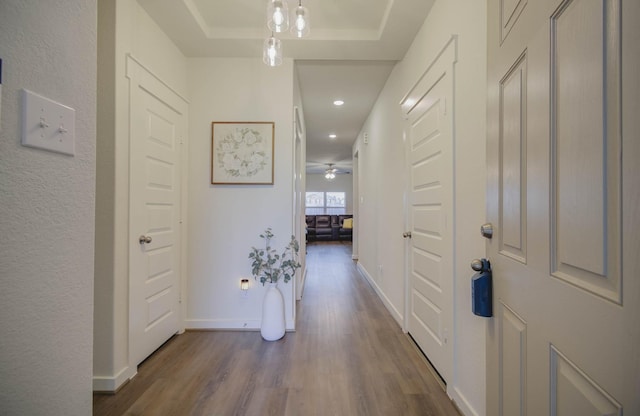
[211,121,275,185]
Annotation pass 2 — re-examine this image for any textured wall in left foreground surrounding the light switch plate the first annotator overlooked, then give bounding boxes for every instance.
[0,0,97,415]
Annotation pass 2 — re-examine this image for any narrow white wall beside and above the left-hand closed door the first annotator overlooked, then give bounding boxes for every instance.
[93,0,188,391]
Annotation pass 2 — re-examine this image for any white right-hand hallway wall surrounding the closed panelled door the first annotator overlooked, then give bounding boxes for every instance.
[354,0,486,415]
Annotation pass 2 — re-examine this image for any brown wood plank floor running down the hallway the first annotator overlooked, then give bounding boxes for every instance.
[93,243,458,416]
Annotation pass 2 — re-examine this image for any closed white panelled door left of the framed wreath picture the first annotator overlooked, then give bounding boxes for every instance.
[128,59,186,364]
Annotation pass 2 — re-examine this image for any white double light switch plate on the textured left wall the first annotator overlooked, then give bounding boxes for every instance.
[22,89,76,156]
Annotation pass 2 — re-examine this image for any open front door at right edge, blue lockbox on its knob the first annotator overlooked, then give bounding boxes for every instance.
[487,0,640,416]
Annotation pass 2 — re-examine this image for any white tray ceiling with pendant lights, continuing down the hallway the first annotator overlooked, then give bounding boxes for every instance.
[138,0,434,173]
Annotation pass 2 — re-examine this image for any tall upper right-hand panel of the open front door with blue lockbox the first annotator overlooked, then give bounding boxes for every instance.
[551,1,621,303]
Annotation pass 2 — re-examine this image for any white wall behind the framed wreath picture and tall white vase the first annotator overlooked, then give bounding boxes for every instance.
[183,58,295,329]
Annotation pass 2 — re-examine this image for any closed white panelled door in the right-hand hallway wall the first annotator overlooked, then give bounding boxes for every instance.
[401,42,455,381]
